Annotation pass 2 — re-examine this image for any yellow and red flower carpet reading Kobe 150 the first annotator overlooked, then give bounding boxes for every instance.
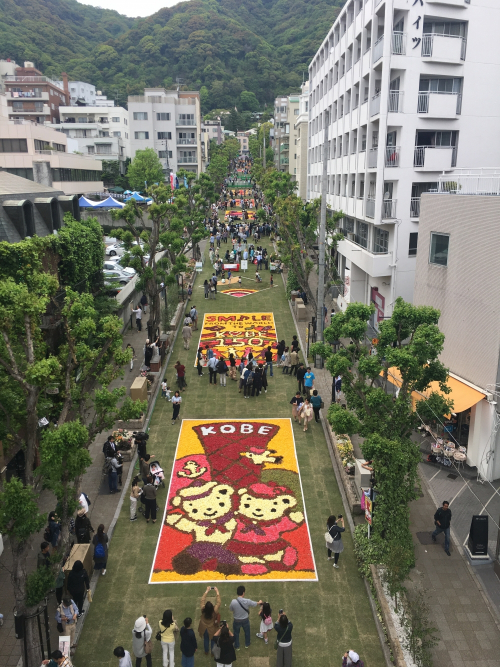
[194,312,278,366]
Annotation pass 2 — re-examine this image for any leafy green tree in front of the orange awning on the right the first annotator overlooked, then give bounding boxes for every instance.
[311,298,452,580]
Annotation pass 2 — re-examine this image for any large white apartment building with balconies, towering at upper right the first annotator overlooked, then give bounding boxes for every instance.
[308,0,500,324]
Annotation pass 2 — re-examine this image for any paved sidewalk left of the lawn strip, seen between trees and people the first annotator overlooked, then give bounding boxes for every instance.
[0,315,172,667]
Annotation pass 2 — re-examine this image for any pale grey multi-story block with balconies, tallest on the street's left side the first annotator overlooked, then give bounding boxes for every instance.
[128,88,203,175]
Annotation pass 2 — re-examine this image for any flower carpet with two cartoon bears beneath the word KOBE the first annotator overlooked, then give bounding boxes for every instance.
[149,419,317,584]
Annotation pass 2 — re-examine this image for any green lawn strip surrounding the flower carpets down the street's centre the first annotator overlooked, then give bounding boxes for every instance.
[74,232,385,667]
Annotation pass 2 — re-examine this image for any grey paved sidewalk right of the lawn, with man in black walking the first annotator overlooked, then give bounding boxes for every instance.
[288,266,500,667]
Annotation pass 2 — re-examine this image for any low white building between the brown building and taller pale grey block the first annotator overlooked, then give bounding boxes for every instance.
[57,106,131,173]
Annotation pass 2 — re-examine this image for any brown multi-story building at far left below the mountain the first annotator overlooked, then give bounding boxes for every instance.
[4,61,69,123]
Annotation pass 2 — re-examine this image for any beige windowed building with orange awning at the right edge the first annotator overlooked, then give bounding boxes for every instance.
[414,174,500,481]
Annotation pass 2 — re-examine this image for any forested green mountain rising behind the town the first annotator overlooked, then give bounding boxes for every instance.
[0,0,344,111]
